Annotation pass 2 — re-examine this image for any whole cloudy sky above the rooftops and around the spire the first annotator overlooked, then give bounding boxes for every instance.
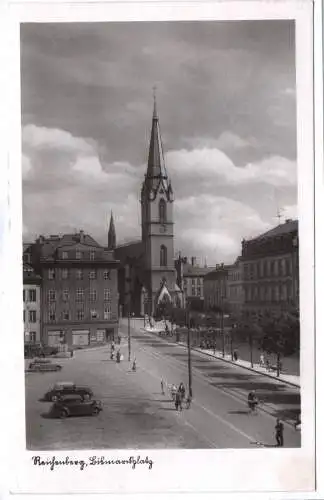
[21,21,297,265]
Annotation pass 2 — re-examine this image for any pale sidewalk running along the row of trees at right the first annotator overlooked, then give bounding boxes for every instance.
[141,327,300,388]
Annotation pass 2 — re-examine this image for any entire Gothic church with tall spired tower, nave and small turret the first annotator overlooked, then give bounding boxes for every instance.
[108,96,184,316]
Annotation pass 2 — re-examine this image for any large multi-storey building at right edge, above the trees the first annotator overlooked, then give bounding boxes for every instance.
[241,220,299,315]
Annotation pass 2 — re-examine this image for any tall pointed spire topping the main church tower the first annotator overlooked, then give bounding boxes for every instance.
[146,89,168,190]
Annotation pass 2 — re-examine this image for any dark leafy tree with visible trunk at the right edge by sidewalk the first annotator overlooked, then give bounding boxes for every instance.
[259,311,300,377]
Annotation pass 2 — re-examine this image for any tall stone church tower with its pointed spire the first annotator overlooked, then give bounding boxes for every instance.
[141,92,176,314]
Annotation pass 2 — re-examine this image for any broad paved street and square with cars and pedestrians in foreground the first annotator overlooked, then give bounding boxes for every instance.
[26,323,300,450]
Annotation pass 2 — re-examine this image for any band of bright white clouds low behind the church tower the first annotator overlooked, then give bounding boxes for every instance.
[22,124,296,263]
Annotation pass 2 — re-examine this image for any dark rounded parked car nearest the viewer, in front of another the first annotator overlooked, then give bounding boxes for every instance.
[50,394,102,418]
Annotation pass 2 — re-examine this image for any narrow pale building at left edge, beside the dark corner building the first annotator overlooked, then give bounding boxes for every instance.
[23,263,41,345]
